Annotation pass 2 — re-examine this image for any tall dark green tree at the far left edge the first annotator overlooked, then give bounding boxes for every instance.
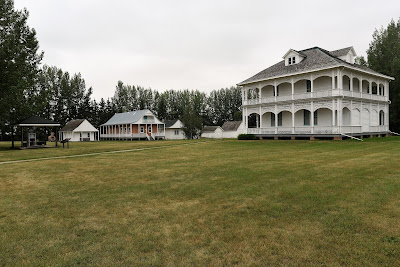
[0,0,43,141]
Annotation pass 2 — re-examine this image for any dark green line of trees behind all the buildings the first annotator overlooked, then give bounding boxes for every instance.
[0,0,400,140]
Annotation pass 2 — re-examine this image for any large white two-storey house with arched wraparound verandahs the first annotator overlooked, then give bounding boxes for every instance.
[238,47,394,139]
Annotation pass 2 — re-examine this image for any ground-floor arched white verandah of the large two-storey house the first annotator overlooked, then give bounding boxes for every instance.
[246,107,389,134]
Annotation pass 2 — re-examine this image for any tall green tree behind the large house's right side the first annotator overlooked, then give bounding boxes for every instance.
[367,19,400,132]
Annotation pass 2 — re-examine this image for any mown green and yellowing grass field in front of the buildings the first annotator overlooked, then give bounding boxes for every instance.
[0,137,400,266]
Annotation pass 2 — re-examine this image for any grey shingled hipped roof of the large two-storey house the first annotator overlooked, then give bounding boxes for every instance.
[238,47,393,85]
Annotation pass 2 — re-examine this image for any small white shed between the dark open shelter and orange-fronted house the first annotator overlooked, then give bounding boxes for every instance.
[58,119,99,142]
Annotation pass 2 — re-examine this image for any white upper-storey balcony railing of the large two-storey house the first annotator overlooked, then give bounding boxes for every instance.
[243,89,389,105]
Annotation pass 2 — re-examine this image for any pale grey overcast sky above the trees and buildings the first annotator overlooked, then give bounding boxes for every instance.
[15,0,400,100]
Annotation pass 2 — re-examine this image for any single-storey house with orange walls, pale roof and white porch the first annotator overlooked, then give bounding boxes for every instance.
[100,109,165,140]
